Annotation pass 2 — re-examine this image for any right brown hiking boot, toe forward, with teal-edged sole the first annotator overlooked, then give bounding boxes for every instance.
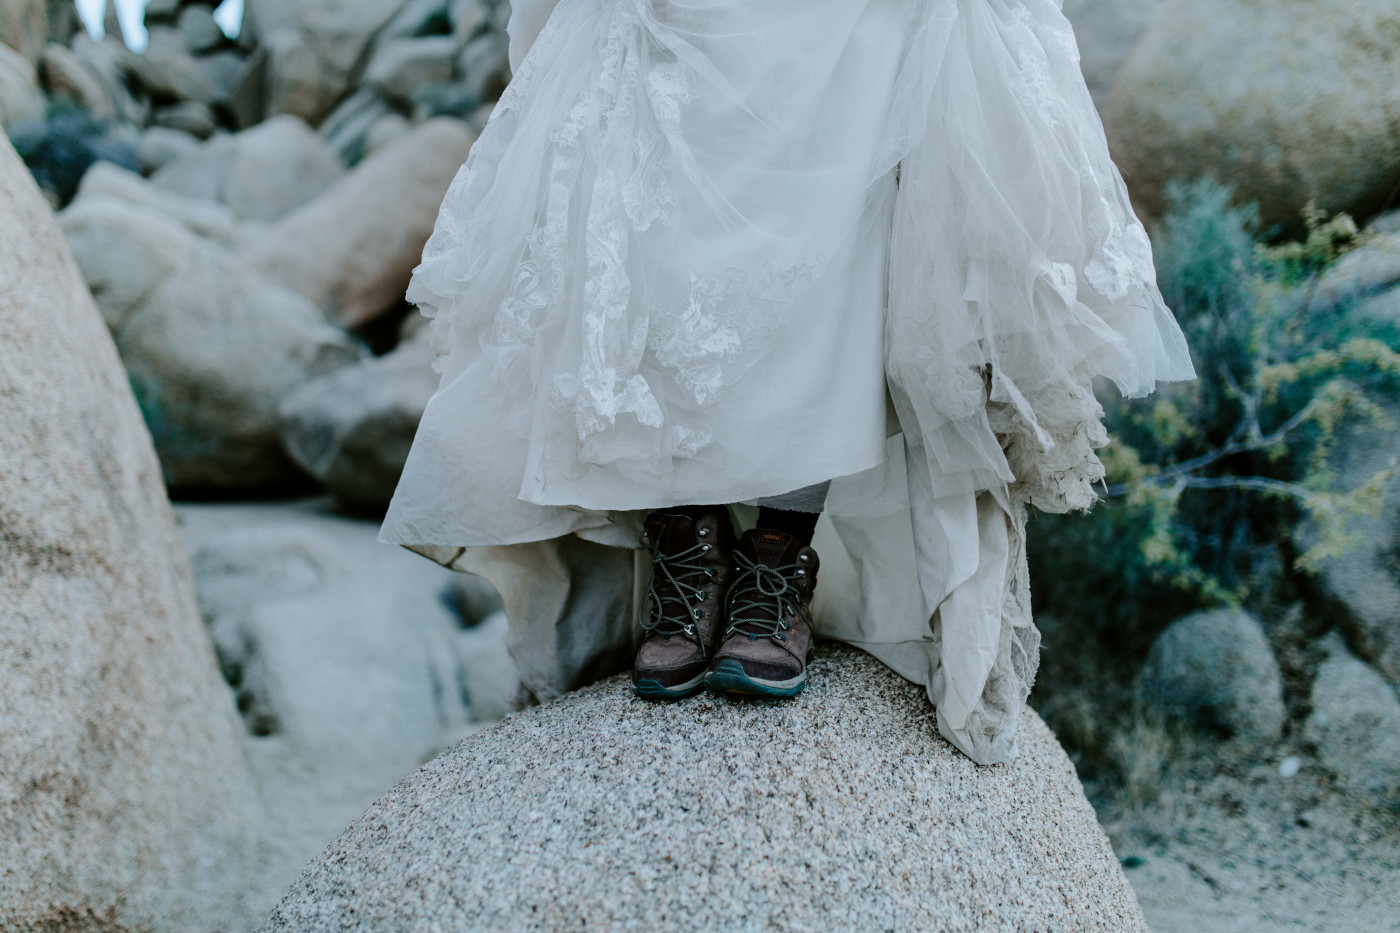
[706,528,818,696]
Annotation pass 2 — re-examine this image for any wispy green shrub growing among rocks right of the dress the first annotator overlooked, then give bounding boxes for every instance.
[1029,181,1400,780]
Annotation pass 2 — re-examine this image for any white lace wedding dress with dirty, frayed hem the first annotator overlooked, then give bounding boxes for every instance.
[381,0,1194,763]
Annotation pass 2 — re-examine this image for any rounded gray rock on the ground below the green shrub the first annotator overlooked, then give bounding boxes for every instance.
[1137,609,1285,741]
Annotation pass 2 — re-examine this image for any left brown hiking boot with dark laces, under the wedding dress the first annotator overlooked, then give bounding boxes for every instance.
[631,506,734,699]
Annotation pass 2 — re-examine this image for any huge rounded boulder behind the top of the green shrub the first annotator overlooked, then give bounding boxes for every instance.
[1103,0,1400,228]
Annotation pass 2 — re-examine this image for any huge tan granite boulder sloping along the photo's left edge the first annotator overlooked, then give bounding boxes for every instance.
[0,134,265,932]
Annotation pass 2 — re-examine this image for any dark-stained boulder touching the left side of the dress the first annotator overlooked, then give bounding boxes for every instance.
[281,325,440,509]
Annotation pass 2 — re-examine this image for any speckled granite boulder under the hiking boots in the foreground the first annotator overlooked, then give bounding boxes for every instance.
[262,647,1147,933]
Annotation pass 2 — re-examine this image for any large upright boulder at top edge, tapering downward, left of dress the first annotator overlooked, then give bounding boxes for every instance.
[255,0,403,125]
